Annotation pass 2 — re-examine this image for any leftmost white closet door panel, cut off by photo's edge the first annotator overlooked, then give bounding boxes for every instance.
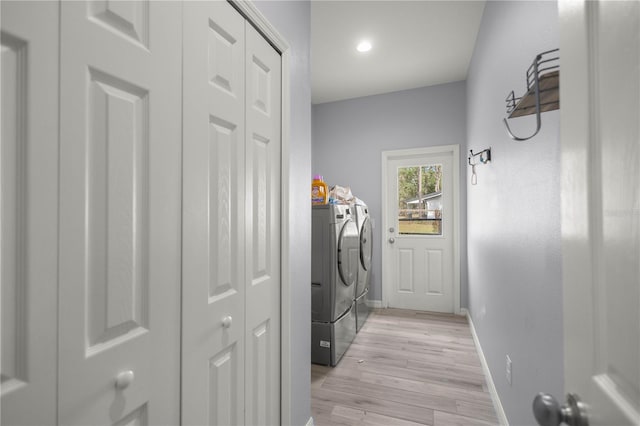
[0,1,59,425]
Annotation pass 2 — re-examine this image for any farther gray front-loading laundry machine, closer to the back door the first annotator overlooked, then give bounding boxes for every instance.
[353,203,373,332]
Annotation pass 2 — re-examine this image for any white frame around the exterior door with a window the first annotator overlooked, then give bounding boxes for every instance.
[380,144,461,315]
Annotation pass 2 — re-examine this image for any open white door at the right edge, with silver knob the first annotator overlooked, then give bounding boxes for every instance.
[556,0,640,425]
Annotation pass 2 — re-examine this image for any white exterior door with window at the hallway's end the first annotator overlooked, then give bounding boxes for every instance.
[382,146,459,313]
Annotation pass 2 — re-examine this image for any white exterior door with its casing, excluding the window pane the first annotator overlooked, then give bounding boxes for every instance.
[382,145,460,313]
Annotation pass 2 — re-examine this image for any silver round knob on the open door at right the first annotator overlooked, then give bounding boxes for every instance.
[533,393,589,426]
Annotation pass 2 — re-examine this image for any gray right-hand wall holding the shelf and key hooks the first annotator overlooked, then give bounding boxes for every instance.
[467,1,563,425]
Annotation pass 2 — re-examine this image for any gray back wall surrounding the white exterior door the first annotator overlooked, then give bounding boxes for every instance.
[307,82,467,306]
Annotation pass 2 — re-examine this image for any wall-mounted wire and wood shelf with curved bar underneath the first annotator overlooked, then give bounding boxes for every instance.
[503,49,560,141]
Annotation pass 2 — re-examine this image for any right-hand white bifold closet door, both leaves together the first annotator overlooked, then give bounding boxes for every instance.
[182,2,281,425]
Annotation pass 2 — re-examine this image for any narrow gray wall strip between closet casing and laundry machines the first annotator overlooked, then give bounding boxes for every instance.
[253,1,311,425]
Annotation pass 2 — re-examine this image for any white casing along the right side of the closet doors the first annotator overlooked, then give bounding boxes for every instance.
[228,0,293,424]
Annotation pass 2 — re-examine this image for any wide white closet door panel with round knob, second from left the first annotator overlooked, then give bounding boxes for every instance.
[59,1,182,425]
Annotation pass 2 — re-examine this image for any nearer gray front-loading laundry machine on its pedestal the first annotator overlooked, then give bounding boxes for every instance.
[311,205,360,366]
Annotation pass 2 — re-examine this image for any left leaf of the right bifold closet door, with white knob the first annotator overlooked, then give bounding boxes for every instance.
[182,1,246,425]
